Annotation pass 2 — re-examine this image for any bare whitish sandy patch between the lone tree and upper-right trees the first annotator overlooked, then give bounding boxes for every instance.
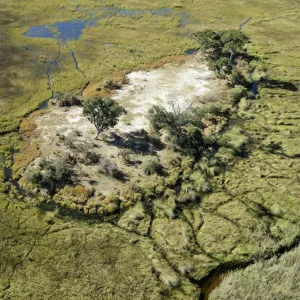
[113,55,218,132]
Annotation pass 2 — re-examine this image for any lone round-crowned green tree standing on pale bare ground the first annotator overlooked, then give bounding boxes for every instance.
[83,98,126,139]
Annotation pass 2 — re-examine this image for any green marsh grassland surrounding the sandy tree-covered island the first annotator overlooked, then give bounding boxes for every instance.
[0,0,300,299]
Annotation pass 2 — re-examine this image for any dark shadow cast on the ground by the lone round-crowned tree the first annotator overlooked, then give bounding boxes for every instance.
[110,130,164,155]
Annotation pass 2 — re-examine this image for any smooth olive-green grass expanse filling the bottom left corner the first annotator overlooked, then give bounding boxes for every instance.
[0,196,199,299]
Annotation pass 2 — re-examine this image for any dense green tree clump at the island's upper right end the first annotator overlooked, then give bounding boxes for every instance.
[194,29,265,104]
